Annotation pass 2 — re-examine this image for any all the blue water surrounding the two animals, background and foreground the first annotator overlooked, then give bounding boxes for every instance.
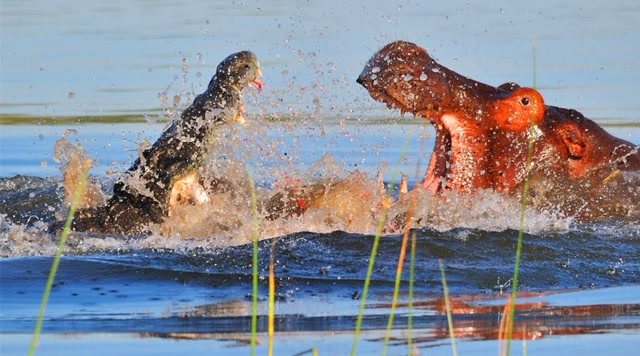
[0,0,640,355]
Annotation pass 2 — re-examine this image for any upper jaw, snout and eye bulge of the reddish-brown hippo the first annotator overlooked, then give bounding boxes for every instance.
[357,41,544,130]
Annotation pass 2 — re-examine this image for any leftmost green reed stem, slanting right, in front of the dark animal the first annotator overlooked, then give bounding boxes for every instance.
[29,160,91,356]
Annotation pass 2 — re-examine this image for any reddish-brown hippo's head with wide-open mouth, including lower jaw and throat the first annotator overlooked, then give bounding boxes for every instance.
[357,41,545,192]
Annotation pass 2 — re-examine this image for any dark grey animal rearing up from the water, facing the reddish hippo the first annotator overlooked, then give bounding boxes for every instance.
[50,51,262,235]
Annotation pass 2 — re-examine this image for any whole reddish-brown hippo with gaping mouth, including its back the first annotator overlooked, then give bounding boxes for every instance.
[357,41,640,219]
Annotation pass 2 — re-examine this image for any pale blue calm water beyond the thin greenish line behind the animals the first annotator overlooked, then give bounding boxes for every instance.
[0,0,640,122]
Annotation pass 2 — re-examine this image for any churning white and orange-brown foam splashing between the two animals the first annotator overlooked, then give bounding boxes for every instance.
[0,120,572,256]
